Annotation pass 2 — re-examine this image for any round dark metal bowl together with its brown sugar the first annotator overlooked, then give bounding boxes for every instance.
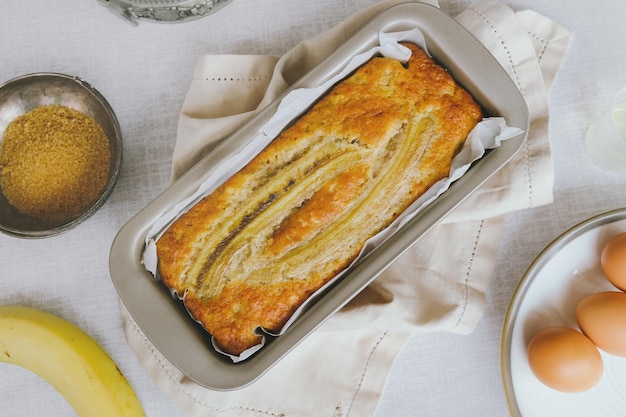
[0,73,122,238]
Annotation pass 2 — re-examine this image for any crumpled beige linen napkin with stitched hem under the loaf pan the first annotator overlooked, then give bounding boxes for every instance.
[122,0,571,417]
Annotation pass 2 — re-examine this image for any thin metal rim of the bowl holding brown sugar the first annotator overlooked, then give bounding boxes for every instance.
[0,72,123,238]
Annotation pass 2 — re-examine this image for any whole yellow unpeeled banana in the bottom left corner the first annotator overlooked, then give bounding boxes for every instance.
[0,306,145,417]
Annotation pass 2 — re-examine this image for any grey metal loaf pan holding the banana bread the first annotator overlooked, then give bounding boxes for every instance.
[110,2,529,390]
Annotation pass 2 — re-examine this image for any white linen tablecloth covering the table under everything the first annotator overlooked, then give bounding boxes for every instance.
[0,0,626,417]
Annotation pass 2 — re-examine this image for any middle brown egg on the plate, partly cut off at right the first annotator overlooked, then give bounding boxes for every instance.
[576,291,626,356]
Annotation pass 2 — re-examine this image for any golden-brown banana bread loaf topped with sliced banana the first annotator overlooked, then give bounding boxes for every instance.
[157,44,482,355]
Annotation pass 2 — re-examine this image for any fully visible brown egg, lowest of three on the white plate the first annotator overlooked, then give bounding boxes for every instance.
[528,326,604,392]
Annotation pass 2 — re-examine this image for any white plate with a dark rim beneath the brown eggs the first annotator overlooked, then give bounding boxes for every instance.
[501,209,626,417]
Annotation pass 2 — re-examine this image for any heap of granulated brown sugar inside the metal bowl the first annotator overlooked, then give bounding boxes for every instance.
[0,105,111,219]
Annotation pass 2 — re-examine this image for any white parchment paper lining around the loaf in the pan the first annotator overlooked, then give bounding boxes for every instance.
[142,28,520,363]
